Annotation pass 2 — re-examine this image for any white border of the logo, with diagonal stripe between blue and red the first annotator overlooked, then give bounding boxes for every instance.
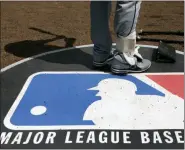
[3,71,184,130]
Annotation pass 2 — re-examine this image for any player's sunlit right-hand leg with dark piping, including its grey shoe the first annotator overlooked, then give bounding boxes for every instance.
[111,0,151,73]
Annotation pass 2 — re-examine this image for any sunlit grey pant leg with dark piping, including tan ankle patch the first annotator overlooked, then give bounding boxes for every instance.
[114,0,141,55]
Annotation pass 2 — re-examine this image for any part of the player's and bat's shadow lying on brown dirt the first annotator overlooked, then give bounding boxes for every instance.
[5,27,76,58]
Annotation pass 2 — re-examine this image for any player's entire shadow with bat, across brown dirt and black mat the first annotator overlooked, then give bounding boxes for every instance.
[5,27,107,71]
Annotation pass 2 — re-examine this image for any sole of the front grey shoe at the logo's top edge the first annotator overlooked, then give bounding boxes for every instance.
[111,64,151,74]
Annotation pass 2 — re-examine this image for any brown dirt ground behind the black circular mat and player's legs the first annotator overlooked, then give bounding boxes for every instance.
[1,1,184,68]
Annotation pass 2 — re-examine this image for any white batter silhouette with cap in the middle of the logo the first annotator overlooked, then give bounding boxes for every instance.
[84,78,184,129]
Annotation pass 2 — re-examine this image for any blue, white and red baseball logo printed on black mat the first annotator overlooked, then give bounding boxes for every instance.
[4,72,184,130]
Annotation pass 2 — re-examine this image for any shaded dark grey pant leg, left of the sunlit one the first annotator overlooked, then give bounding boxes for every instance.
[90,1,112,60]
